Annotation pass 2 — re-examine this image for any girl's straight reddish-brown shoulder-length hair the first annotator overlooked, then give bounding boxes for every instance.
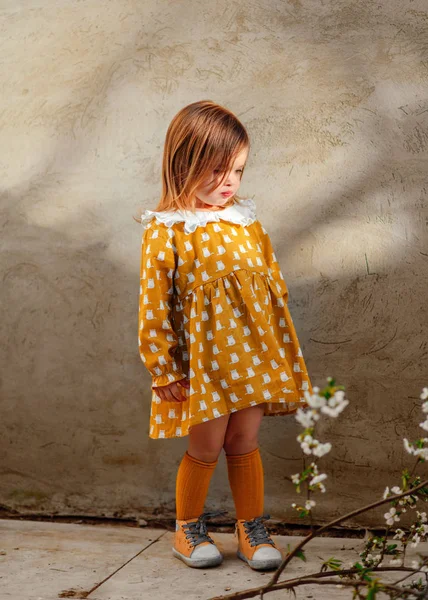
[134,100,250,222]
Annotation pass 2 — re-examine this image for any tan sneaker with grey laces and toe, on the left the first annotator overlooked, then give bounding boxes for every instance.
[172,511,227,568]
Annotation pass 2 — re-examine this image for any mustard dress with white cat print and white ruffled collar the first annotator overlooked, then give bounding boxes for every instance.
[138,199,313,439]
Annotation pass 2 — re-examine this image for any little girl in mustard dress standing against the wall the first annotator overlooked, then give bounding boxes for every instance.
[139,100,312,570]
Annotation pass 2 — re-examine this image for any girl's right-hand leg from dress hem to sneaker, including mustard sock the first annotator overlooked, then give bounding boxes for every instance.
[223,404,265,520]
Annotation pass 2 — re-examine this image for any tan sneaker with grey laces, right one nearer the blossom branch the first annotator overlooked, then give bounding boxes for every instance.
[235,515,283,571]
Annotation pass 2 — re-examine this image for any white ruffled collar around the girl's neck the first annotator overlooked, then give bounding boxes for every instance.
[141,198,257,233]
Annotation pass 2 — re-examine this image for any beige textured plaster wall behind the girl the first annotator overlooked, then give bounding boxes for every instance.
[0,0,428,524]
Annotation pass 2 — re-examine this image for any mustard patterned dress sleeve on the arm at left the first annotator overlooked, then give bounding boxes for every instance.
[138,221,186,389]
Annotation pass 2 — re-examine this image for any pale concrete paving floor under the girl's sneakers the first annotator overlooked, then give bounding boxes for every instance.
[0,519,422,600]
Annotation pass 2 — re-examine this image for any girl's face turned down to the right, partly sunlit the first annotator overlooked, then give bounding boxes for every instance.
[196,150,248,210]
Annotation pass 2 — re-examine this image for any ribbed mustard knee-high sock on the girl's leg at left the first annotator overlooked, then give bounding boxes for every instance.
[175,450,218,521]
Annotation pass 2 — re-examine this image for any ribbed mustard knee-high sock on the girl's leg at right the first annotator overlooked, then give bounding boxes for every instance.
[226,448,264,520]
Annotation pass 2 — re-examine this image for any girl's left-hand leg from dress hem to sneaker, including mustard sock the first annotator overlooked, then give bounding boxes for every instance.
[176,414,230,520]
